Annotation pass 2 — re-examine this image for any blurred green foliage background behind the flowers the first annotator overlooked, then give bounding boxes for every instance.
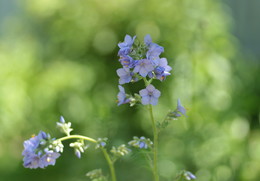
[0,0,260,181]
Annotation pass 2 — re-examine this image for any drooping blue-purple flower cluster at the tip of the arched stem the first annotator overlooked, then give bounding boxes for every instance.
[22,131,63,168]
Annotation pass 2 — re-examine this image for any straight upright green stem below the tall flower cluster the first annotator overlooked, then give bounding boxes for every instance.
[148,104,159,181]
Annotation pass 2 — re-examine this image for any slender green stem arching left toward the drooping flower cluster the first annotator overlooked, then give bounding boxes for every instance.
[57,135,116,181]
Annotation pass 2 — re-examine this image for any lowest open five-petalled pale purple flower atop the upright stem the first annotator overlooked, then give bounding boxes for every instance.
[139,84,161,105]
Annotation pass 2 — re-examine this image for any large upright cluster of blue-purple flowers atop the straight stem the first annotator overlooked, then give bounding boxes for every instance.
[117,35,172,105]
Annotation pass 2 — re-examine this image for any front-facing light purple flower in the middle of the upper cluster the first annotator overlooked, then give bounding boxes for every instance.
[133,59,154,77]
